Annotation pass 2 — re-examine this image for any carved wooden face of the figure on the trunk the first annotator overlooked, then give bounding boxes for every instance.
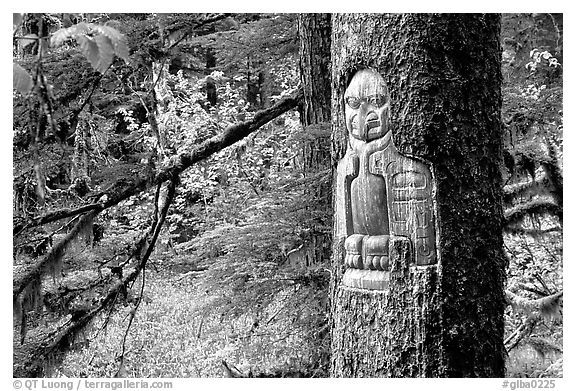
[344,69,390,141]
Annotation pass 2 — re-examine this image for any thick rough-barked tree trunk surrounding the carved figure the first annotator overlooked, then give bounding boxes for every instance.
[332,14,505,377]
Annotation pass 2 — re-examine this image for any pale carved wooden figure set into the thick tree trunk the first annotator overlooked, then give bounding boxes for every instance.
[336,69,436,278]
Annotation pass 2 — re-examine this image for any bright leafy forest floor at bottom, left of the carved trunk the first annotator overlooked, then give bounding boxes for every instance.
[52,262,321,378]
